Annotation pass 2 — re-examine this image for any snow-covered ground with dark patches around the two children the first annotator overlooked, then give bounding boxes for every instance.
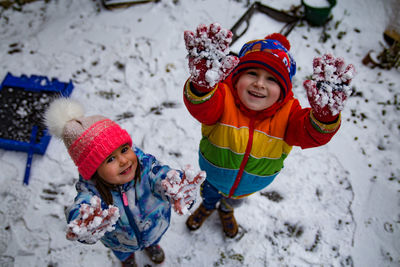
[0,0,400,267]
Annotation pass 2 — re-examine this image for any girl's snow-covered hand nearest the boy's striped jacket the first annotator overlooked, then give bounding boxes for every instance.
[162,165,206,215]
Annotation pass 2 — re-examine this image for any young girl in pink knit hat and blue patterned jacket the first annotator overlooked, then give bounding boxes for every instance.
[45,98,205,266]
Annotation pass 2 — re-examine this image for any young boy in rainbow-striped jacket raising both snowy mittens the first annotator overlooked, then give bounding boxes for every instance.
[184,24,354,238]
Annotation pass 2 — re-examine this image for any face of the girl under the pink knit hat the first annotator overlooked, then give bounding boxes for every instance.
[97,144,138,185]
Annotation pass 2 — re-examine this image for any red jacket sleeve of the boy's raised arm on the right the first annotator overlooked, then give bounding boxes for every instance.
[285,99,341,149]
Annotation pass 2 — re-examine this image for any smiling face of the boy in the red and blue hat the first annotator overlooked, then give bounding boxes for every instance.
[236,68,281,111]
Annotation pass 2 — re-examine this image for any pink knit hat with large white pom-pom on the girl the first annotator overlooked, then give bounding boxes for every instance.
[45,98,132,180]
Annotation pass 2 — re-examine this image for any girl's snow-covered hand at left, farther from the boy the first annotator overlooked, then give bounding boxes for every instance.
[66,196,119,244]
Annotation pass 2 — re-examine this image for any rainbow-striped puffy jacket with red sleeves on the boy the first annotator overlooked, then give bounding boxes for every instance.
[184,78,340,198]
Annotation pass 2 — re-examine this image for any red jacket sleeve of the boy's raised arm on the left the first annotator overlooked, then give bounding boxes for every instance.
[183,80,225,125]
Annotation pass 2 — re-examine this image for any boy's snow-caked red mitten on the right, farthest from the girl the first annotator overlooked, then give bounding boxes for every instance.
[303,54,355,123]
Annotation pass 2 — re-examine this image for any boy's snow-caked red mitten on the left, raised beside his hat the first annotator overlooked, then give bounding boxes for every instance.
[184,23,239,92]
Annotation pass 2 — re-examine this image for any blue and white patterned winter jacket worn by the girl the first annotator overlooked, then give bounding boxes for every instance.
[66,147,171,252]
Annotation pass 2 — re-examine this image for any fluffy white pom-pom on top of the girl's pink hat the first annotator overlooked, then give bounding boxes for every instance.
[44,98,84,138]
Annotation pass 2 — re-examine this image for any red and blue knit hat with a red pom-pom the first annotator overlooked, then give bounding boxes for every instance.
[232,33,296,99]
